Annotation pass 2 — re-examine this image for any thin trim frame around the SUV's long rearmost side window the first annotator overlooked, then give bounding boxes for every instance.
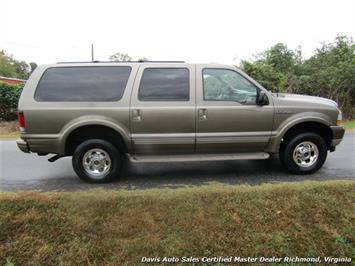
[33,65,132,103]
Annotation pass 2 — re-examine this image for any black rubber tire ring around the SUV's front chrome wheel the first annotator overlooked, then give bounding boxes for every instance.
[279,132,328,175]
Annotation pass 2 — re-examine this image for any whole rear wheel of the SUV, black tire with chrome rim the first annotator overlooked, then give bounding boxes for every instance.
[72,139,122,183]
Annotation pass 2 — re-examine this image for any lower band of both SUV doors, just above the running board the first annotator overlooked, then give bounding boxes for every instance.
[131,132,270,155]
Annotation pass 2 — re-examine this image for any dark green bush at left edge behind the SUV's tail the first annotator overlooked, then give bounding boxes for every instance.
[0,82,22,121]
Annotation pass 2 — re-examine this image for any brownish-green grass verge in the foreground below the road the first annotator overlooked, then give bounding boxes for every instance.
[0,181,355,265]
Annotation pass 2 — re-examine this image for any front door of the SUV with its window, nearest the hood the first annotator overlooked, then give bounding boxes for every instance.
[196,65,274,153]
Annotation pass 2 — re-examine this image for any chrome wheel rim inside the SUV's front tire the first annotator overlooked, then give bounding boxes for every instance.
[293,141,319,167]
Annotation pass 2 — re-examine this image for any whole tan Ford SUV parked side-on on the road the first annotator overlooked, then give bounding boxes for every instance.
[17,62,344,182]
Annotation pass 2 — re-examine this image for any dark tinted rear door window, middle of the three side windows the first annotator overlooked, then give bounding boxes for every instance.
[138,68,189,101]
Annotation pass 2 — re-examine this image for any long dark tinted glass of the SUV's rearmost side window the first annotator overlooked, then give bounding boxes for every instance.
[35,66,131,102]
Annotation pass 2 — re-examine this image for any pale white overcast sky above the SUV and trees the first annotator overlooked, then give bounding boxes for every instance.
[0,0,355,64]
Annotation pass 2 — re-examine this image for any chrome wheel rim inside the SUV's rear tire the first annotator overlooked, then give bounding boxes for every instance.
[82,148,111,179]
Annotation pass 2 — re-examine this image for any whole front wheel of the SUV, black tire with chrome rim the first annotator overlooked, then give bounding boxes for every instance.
[280,132,328,175]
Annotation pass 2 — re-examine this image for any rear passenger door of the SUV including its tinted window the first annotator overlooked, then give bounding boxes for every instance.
[130,63,195,154]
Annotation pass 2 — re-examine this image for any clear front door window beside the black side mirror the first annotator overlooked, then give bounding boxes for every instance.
[203,68,257,104]
